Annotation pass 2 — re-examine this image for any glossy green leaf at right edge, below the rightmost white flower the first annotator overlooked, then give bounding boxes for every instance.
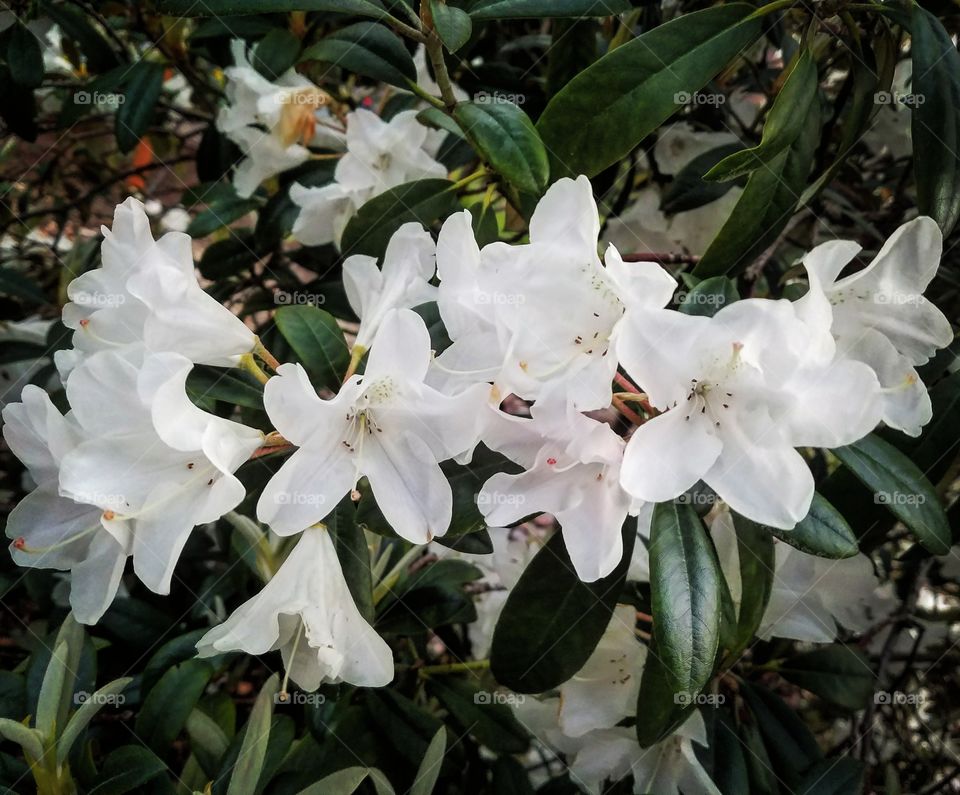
[833,434,951,555]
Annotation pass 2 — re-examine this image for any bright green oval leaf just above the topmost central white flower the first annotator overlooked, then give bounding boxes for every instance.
[453,100,550,195]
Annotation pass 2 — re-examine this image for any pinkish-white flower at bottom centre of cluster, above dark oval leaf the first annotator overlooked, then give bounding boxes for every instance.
[477,399,636,582]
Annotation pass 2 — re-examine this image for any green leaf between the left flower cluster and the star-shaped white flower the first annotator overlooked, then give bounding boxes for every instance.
[274,306,350,389]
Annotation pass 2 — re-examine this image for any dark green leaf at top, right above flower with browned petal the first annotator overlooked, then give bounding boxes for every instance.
[300,22,417,88]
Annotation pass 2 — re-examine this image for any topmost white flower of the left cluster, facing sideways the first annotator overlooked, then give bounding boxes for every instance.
[55,198,255,377]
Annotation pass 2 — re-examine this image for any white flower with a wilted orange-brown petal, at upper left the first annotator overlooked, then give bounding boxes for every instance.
[217,39,344,197]
